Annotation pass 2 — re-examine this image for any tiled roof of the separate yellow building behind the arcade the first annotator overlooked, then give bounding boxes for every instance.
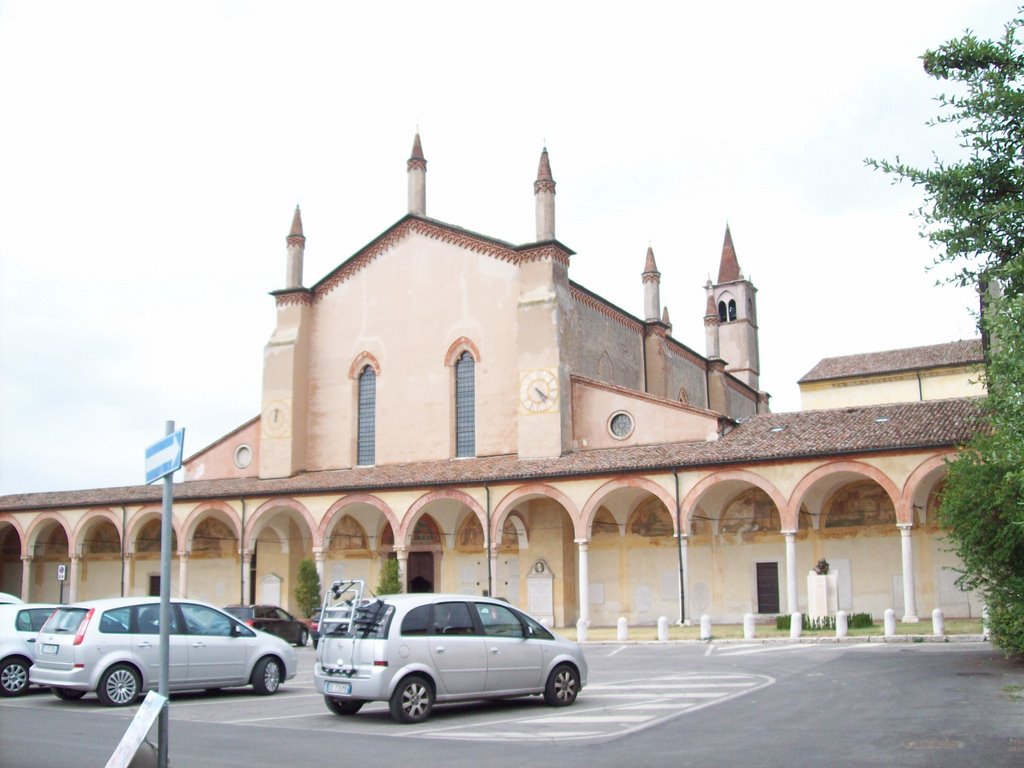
[798,339,984,384]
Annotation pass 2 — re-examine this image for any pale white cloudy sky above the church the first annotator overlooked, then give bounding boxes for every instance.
[0,0,1017,494]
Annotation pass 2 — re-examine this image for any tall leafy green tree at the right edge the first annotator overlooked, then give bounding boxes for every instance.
[866,9,1024,653]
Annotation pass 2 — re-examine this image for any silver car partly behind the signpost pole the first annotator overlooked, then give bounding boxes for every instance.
[30,597,298,707]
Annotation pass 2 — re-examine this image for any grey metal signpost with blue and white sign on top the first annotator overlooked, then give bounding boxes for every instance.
[145,421,185,768]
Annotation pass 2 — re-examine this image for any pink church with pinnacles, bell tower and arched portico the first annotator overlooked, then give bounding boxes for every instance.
[0,135,980,627]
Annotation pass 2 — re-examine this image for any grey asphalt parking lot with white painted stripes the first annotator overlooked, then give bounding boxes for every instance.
[0,642,1024,768]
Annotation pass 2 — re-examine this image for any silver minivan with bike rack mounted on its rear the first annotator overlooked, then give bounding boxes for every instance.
[313,594,587,723]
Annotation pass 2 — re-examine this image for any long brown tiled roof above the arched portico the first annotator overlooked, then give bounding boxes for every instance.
[0,398,981,512]
